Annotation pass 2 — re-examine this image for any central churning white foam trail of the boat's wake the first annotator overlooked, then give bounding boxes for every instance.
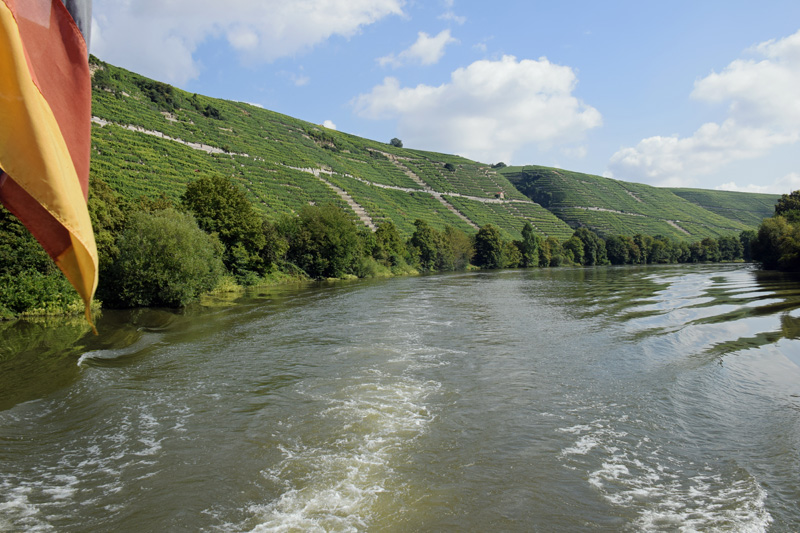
[247,371,439,533]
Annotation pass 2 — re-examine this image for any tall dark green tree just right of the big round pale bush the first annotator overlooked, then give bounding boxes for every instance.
[181,175,267,276]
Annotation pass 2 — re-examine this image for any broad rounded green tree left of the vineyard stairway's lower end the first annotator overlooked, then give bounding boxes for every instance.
[287,204,361,279]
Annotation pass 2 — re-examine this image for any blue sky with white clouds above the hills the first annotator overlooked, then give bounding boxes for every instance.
[92,0,800,193]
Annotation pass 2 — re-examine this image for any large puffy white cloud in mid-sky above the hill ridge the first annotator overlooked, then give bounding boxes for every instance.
[353,56,602,162]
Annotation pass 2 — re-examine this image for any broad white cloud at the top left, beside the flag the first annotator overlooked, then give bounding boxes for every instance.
[92,0,405,84]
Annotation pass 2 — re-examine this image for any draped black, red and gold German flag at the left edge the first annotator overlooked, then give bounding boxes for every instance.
[0,0,98,323]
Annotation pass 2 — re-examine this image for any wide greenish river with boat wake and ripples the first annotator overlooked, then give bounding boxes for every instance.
[0,265,800,532]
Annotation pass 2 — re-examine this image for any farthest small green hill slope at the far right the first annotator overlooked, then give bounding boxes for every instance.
[669,189,780,227]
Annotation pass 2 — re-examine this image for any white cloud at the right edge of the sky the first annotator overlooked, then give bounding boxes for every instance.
[609,31,800,188]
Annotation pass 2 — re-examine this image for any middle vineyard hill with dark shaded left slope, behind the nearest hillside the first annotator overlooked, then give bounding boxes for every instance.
[500,166,756,240]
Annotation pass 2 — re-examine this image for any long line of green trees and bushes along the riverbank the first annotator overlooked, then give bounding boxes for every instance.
[0,176,800,319]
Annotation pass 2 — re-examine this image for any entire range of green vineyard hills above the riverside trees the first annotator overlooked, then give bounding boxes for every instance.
[90,57,774,240]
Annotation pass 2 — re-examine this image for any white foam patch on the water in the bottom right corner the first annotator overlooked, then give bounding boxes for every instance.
[558,420,772,532]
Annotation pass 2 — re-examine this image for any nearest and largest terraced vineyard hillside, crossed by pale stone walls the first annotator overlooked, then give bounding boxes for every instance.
[91,58,572,239]
